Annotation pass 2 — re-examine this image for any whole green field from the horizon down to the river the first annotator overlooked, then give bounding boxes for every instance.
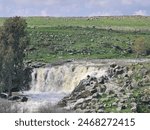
[0,16,150,62]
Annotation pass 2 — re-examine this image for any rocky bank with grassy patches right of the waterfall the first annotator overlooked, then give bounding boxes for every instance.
[58,63,150,113]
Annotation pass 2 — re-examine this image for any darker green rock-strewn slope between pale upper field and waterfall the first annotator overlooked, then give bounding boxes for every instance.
[27,26,150,62]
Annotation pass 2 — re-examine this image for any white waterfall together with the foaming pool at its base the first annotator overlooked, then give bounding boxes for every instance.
[20,64,106,111]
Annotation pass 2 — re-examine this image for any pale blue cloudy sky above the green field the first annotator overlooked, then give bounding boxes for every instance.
[0,0,150,17]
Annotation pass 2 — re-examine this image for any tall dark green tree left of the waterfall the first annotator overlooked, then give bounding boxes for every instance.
[0,17,29,95]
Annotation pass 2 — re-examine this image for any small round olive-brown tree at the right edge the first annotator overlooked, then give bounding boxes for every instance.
[132,37,150,57]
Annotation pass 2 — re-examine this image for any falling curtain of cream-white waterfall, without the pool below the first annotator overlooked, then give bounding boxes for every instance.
[30,64,105,93]
